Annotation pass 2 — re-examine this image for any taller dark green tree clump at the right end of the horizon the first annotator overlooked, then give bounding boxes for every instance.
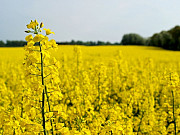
[121,26,180,50]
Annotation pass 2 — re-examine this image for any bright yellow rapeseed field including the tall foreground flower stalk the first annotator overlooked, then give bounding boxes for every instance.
[0,21,180,135]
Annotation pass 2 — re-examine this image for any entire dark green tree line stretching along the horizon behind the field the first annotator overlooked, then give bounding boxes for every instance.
[0,26,180,50]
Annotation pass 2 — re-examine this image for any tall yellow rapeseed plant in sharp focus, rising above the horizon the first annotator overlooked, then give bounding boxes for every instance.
[24,20,62,134]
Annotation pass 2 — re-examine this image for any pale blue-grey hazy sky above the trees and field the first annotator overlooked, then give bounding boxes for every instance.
[0,0,180,42]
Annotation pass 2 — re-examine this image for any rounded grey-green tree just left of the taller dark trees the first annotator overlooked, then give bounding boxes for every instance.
[121,33,145,45]
